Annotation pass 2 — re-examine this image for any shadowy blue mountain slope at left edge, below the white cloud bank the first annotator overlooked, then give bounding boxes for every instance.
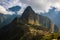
[0,13,16,28]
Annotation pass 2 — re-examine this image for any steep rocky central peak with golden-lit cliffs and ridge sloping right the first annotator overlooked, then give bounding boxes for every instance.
[21,6,58,32]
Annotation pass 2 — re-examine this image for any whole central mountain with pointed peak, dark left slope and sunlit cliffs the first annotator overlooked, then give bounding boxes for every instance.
[0,6,58,40]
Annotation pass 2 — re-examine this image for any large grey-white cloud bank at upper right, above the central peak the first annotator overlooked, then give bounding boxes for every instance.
[20,0,60,12]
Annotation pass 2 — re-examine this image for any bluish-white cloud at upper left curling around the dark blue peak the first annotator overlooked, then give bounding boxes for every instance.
[0,0,26,14]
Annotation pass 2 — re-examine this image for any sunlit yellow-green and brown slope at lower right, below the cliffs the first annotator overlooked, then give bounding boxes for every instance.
[20,25,60,40]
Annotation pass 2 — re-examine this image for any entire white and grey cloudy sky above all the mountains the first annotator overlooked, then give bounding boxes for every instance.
[0,0,60,14]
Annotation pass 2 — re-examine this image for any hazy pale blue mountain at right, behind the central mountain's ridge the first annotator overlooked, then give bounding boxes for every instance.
[41,7,60,27]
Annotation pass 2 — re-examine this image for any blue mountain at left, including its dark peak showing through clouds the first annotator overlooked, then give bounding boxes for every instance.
[0,6,21,28]
